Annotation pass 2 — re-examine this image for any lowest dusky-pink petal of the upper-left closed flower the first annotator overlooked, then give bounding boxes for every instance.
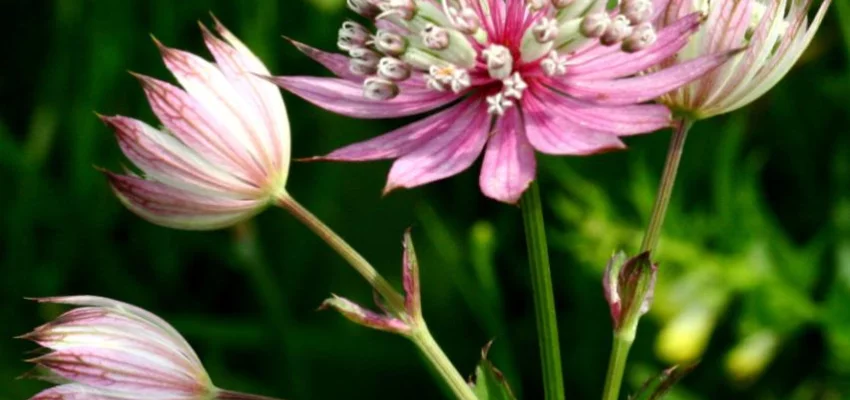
[106,172,263,230]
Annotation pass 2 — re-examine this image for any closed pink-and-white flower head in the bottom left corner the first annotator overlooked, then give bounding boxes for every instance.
[23,296,218,400]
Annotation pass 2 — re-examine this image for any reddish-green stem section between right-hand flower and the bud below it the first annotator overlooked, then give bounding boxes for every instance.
[640,119,693,253]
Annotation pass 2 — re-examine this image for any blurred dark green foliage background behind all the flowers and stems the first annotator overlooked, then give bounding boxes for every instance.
[0,0,850,400]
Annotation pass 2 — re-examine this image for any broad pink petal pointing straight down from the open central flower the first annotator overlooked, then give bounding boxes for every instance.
[479,108,537,204]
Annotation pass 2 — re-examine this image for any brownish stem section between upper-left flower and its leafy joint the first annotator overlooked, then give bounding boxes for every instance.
[277,195,404,312]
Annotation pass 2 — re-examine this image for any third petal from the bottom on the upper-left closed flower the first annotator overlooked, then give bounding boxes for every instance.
[135,74,264,183]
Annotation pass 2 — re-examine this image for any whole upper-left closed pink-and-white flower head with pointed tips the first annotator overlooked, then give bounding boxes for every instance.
[102,21,290,229]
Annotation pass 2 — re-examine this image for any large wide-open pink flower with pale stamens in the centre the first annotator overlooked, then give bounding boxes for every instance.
[274,0,727,203]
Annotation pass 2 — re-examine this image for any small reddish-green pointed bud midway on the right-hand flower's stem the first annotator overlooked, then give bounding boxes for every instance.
[602,252,658,336]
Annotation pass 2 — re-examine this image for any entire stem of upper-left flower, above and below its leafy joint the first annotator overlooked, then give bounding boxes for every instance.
[276,194,476,400]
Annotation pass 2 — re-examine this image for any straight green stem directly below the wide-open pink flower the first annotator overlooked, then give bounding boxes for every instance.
[520,182,565,400]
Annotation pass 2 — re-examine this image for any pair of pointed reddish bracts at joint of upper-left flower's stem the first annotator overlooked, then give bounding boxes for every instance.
[319,231,423,336]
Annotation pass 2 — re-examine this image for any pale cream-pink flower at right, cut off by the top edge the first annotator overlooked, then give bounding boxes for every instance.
[661,0,831,119]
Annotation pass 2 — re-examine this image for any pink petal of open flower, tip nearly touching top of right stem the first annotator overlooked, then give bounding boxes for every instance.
[529,83,672,136]
